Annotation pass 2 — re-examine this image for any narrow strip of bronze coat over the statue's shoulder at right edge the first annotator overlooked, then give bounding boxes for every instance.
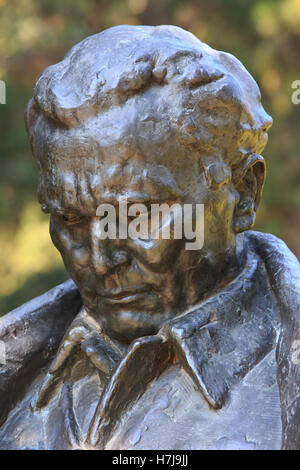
[245,232,300,449]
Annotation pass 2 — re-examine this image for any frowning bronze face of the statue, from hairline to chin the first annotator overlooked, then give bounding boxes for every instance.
[46,107,239,340]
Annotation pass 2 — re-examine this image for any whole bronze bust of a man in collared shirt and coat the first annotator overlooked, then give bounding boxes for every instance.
[0,25,300,450]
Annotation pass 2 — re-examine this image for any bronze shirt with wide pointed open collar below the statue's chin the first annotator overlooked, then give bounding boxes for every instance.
[0,232,300,450]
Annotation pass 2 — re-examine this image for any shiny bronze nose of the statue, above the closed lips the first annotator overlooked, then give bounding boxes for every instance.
[90,217,130,275]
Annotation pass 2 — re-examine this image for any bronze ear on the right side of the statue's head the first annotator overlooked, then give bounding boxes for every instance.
[233,153,266,233]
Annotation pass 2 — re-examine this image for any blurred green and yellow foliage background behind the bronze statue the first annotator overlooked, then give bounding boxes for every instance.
[0,0,300,315]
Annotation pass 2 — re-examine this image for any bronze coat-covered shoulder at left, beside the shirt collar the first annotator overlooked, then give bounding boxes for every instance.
[0,280,81,424]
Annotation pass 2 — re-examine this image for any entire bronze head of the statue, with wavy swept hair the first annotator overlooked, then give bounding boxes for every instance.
[26,26,272,340]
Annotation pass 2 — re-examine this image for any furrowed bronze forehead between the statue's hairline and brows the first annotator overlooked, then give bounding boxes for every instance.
[39,106,204,212]
